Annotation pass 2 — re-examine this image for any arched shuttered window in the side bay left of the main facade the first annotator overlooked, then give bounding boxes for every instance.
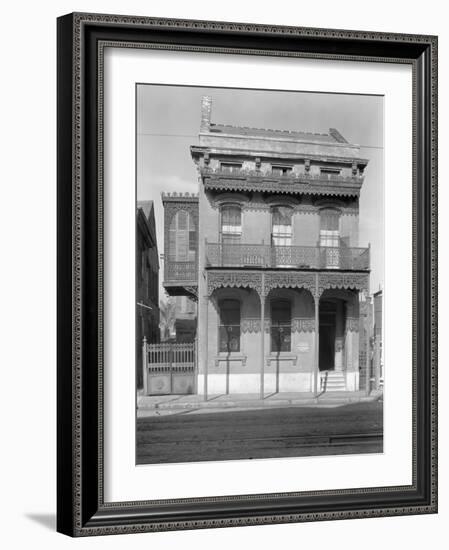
[168,210,197,262]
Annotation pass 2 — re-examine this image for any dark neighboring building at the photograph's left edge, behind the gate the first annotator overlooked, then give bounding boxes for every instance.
[136,201,160,388]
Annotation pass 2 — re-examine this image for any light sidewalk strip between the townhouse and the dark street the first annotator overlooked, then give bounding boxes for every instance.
[137,391,382,416]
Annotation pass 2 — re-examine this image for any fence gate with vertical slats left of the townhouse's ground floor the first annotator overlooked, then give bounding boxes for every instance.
[143,342,196,395]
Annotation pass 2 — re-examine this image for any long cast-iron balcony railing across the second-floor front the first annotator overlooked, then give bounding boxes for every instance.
[206,243,370,271]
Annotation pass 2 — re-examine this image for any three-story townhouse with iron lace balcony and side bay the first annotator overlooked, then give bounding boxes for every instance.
[162,97,370,396]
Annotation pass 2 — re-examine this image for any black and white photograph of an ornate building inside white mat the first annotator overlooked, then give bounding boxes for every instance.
[135,83,384,464]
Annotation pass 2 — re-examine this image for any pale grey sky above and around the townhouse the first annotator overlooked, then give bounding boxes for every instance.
[136,84,384,297]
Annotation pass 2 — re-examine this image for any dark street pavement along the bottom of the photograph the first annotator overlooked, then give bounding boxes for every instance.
[136,400,383,464]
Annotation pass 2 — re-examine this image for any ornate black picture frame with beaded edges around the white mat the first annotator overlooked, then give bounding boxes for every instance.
[57,13,437,536]
